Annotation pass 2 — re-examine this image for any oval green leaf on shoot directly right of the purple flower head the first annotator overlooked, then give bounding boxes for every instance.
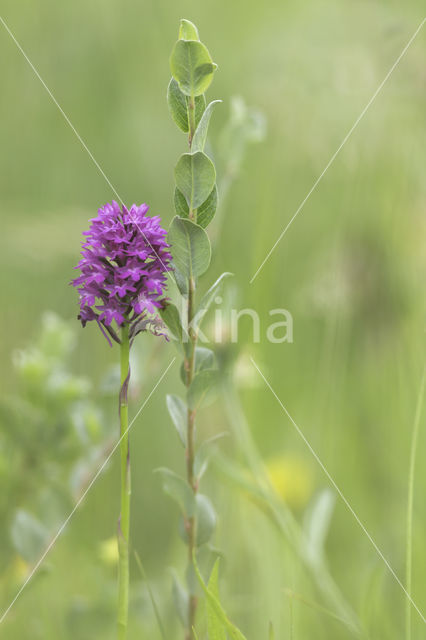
[168,216,211,279]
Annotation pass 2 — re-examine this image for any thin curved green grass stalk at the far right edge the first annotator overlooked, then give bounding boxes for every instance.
[405,368,426,640]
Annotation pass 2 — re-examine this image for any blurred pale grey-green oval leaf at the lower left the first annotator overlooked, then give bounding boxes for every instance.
[10,509,49,563]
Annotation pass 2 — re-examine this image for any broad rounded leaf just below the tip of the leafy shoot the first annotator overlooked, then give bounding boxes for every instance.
[170,40,217,96]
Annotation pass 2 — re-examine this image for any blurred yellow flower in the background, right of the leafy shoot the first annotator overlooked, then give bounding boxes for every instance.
[266,454,314,509]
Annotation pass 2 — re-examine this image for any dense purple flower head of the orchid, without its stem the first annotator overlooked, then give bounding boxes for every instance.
[71,202,172,341]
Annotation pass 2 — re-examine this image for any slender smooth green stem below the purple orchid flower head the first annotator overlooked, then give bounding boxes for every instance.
[117,325,130,640]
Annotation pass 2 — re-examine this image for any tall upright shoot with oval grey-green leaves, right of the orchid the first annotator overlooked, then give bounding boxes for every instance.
[160,20,230,640]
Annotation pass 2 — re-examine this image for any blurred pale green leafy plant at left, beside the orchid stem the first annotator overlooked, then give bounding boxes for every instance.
[0,313,111,563]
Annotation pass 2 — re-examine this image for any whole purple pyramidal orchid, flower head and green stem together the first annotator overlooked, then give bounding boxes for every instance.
[71,202,171,640]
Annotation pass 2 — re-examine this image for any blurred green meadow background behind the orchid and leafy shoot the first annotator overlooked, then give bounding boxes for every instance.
[0,0,426,640]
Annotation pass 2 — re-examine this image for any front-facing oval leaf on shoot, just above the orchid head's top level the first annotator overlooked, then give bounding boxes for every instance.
[175,151,216,210]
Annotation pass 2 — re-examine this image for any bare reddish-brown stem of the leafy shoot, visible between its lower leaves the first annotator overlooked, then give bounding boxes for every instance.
[185,278,198,640]
